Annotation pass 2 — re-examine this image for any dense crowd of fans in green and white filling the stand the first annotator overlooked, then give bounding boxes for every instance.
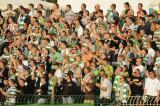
[0,2,160,105]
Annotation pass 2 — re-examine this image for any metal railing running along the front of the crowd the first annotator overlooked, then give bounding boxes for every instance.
[0,95,160,106]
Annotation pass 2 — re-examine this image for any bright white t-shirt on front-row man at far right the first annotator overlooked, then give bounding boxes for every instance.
[144,78,160,96]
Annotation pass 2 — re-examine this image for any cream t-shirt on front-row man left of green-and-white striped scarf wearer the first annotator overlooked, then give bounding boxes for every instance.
[100,79,112,99]
